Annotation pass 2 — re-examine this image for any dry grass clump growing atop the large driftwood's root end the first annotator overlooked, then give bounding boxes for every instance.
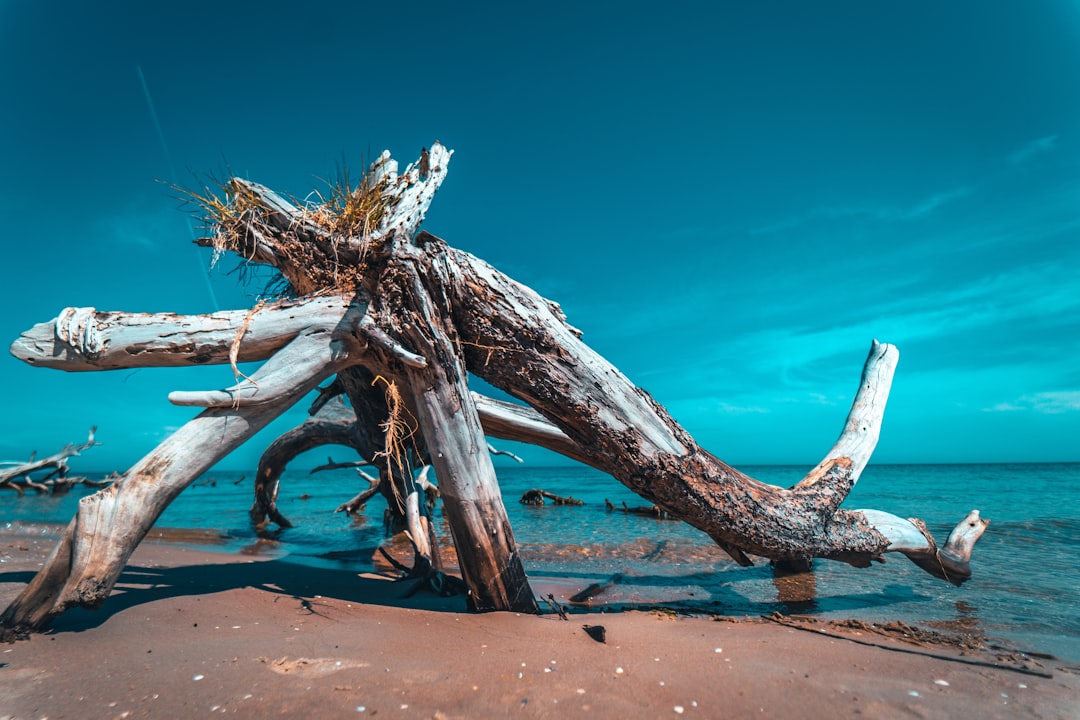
[180,163,396,295]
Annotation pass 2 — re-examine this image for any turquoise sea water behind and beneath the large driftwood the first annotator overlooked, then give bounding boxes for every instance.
[0,463,1080,661]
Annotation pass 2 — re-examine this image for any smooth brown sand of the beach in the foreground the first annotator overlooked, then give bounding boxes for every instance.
[0,536,1080,720]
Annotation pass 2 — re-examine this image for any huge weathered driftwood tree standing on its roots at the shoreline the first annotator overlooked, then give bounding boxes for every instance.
[0,144,986,634]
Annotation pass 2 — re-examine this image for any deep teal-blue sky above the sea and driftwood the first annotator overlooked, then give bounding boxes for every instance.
[0,0,1080,471]
